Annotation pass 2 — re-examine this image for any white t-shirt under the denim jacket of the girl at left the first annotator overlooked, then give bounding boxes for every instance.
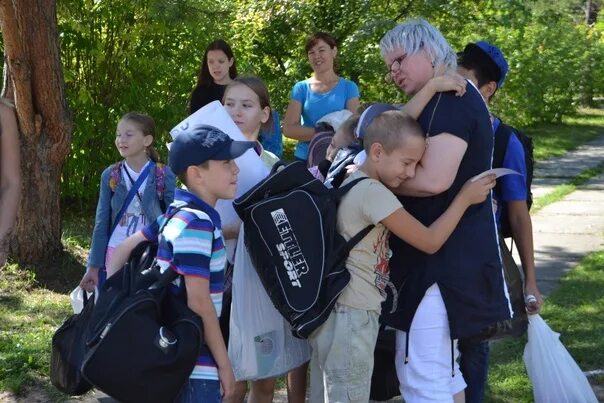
[107,161,152,248]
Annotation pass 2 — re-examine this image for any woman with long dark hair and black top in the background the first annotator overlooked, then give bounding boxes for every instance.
[189,39,237,113]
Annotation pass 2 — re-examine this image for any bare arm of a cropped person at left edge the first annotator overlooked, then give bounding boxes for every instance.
[0,104,21,267]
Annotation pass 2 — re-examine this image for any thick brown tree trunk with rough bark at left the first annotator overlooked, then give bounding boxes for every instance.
[0,0,72,264]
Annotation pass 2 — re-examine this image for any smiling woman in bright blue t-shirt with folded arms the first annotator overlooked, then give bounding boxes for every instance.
[283,32,360,161]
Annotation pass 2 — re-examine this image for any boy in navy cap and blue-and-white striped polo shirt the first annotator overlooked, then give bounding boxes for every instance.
[107,125,256,403]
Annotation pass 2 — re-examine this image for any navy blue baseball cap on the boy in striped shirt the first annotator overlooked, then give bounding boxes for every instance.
[168,125,256,175]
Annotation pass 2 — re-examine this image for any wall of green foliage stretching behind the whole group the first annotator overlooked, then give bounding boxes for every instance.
[2,0,604,206]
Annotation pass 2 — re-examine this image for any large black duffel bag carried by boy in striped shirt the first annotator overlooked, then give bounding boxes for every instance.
[82,208,203,403]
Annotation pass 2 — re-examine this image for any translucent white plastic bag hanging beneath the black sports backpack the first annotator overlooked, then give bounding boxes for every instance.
[228,226,310,381]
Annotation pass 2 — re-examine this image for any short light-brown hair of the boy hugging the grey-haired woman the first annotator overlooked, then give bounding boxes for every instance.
[363,111,425,154]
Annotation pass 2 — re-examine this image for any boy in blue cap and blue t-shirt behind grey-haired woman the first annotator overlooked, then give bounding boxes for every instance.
[458,41,543,403]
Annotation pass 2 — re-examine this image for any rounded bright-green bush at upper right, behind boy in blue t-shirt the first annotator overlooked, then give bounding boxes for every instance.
[494,18,590,124]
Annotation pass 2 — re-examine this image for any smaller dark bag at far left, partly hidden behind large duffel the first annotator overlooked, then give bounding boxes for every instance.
[50,292,94,396]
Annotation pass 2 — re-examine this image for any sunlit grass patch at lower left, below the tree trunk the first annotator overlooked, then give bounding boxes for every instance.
[0,214,94,401]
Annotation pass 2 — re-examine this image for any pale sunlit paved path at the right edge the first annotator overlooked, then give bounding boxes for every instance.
[71,136,604,403]
